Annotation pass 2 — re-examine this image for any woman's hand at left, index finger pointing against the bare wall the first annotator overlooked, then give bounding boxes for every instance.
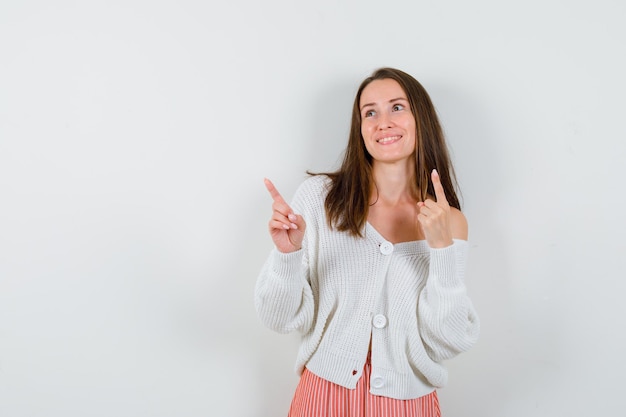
[265,178,306,253]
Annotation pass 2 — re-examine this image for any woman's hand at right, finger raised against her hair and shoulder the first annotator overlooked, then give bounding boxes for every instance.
[417,169,452,248]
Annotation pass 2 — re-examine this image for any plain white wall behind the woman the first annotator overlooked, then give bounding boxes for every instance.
[0,0,626,417]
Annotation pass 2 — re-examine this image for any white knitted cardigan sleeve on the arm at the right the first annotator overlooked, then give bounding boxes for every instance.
[418,240,480,362]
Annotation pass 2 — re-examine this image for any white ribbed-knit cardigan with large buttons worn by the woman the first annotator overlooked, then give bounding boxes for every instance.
[255,176,480,399]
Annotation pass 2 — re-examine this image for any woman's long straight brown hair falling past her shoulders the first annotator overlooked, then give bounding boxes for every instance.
[310,68,461,236]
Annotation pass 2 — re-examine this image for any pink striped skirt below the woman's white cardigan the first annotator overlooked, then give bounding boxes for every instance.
[288,357,441,417]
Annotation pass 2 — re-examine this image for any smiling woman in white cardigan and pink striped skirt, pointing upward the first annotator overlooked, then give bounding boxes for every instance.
[255,68,479,417]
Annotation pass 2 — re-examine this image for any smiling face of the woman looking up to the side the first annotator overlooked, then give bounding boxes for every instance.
[359,79,416,163]
